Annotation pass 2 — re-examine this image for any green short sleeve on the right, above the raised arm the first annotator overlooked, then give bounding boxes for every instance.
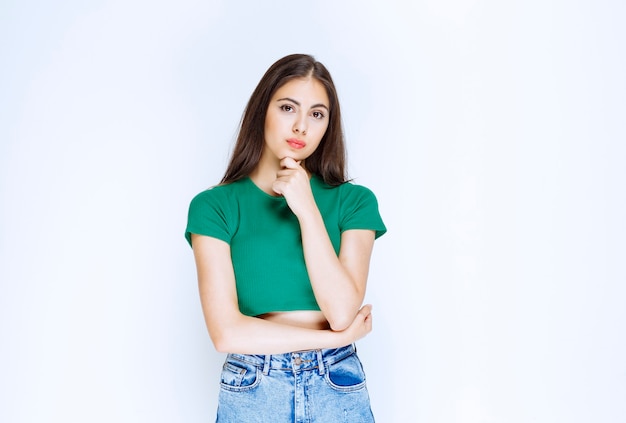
[340,183,387,238]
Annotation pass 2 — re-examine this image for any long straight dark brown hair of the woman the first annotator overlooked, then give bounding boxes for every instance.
[221,54,347,185]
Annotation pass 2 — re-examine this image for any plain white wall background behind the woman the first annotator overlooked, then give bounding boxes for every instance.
[0,0,626,423]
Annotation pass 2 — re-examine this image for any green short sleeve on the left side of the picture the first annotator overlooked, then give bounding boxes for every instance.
[185,188,232,245]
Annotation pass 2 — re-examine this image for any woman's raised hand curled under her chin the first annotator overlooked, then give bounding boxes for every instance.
[272,157,317,218]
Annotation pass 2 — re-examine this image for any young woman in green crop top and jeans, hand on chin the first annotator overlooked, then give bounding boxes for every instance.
[186,54,386,423]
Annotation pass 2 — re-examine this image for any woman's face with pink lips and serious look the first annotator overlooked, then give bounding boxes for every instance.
[263,78,330,166]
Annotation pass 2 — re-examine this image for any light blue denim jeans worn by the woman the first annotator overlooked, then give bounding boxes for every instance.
[217,345,374,423]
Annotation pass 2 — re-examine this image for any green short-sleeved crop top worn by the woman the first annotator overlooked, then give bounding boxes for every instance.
[185,176,386,316]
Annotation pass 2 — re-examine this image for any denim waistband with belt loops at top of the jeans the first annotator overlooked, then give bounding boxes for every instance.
[226,344,356,375]
